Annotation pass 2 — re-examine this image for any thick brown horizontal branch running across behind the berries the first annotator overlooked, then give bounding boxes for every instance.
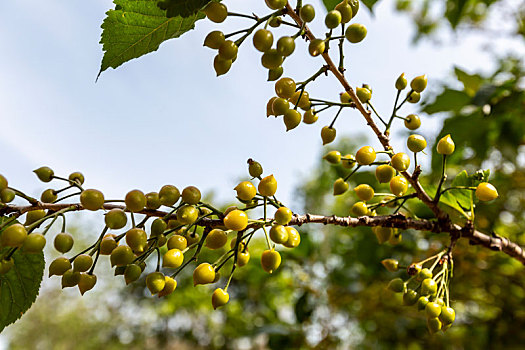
[0,203,525,264]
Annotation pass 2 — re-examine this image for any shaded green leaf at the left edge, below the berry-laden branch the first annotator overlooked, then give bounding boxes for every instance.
[0,217,45,332]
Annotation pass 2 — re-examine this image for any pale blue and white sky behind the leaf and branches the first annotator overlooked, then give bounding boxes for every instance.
[0,0,523,215]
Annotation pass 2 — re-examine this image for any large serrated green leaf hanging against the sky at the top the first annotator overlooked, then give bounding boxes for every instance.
[99,0,204,75]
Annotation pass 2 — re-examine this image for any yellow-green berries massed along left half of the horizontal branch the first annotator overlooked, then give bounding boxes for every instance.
[0,159,301,308]
